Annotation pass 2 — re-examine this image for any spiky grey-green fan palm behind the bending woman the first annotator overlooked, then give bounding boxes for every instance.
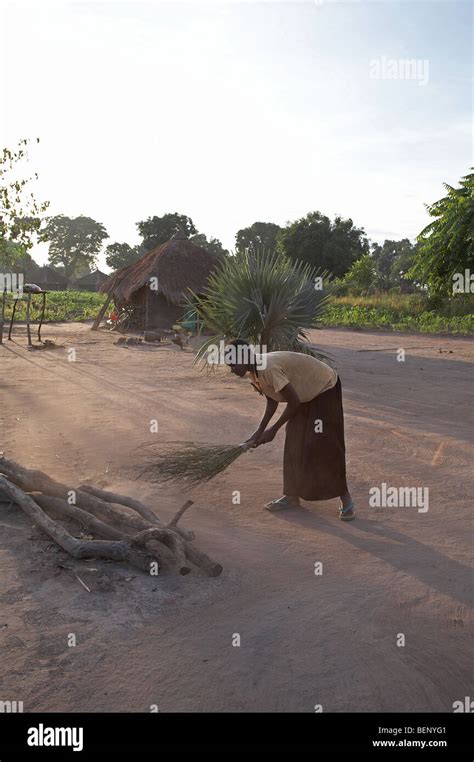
[190,245,329,359]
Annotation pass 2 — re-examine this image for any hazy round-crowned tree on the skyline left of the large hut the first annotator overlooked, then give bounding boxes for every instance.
[40,214,109,278]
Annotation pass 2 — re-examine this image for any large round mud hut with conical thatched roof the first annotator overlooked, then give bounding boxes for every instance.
[100,233,219,329]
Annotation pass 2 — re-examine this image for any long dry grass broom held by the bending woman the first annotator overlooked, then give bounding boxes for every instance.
[142,442,252,485]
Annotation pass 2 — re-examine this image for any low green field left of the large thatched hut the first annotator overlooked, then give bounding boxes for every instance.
[5,291,105,323]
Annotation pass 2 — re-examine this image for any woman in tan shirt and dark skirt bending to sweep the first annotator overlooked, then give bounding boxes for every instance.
[226,339,355,521]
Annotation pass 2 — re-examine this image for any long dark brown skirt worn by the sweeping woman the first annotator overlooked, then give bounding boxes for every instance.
[283,379,347,500]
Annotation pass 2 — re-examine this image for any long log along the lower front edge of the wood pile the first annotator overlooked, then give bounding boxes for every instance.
[0,476,159,571]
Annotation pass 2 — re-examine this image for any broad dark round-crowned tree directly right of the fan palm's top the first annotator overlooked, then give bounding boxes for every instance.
[277,212,369,277]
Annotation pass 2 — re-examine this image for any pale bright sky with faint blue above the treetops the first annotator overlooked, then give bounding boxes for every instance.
[0,0,473,270]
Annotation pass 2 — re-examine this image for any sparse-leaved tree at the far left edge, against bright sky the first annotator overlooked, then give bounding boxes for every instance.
[0,138,49,267]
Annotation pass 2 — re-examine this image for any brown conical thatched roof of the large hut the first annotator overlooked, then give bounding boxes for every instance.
[100,234,219,304]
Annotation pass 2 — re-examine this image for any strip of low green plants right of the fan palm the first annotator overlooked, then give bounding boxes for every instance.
[319,294,474,335]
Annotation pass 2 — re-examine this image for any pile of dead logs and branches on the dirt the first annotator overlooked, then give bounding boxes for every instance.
[0,457,222,577]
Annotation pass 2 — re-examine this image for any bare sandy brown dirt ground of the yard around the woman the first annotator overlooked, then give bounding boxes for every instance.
[0,324,474,712]
